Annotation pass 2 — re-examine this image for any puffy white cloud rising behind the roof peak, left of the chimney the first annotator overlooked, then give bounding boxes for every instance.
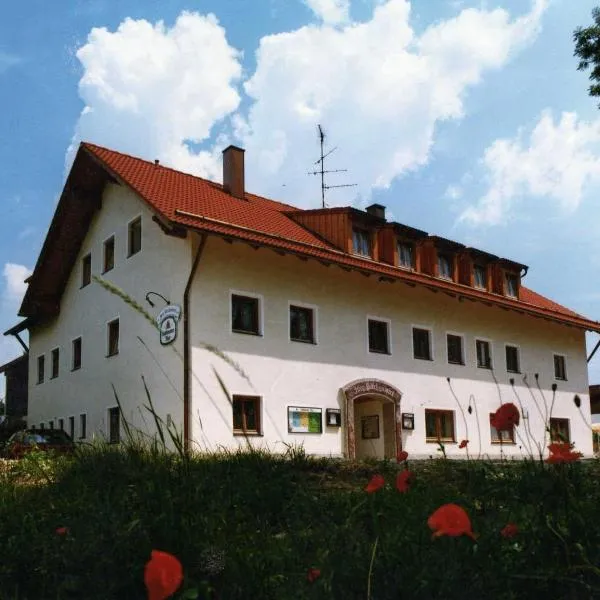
[67,12,242,177]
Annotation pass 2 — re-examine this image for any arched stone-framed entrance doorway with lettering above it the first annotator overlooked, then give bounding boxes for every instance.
[342,379,402,459]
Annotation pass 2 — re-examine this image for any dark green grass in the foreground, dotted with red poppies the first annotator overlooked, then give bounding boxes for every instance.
[0,444,600,600]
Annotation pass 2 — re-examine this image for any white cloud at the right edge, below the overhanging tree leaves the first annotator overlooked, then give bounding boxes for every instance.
[459,109,600,225]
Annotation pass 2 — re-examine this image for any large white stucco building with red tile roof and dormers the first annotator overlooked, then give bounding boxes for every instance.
[5,143,600,458]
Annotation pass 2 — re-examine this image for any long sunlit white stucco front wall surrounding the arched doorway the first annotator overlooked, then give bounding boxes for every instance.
[191,238,592,457]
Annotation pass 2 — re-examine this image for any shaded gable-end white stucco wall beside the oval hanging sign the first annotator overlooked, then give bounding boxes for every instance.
[28,184,191,440]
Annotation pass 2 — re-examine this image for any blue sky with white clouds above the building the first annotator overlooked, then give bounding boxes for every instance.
[0,0,600,397]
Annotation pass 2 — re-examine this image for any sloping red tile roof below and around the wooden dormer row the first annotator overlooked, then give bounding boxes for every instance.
[81,143,600,332]
